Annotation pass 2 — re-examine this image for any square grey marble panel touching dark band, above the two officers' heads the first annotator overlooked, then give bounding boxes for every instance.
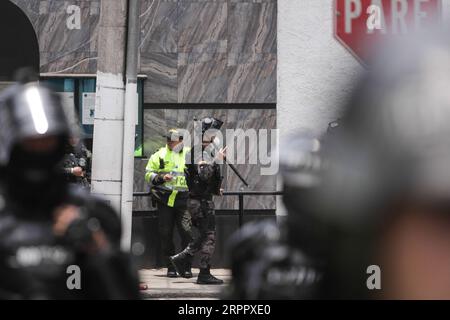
[178,54,228,103]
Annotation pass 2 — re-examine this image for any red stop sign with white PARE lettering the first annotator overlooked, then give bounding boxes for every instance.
[334,0,441,62]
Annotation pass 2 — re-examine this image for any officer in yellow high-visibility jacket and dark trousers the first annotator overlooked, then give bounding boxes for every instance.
[145,129,192,278]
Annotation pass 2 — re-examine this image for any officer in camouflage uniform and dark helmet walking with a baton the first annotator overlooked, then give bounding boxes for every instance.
[170,118,225,284]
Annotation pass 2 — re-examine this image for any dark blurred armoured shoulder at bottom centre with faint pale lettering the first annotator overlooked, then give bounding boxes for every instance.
[225,220,321,300]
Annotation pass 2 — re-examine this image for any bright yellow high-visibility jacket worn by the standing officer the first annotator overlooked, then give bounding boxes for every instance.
[145,145,190,207]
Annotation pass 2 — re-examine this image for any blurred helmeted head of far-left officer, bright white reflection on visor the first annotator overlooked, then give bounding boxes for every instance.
[0,82,70,211]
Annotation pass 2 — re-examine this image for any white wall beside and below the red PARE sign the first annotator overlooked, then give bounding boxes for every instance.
[277,0,450,215]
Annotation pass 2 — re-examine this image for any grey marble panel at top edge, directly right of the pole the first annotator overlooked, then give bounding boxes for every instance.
[140,0,178,53]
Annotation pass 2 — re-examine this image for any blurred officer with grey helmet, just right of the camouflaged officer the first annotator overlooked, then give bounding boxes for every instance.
[224,134,322,300]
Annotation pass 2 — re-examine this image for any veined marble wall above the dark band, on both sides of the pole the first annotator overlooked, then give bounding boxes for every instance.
[11,0,277,103]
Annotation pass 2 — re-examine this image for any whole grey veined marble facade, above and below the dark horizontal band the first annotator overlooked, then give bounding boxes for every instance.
[7,0,277,210]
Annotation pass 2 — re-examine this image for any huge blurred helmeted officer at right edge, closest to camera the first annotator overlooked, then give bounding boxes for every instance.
[297,35,450,299]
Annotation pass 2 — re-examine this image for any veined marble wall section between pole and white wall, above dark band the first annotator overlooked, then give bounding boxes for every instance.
[140,0,277,103]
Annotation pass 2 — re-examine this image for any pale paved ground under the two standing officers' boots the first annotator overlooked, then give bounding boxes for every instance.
[140,269,230,300]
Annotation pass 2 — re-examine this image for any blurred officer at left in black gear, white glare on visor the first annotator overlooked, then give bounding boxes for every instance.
[0,83,139,299]
